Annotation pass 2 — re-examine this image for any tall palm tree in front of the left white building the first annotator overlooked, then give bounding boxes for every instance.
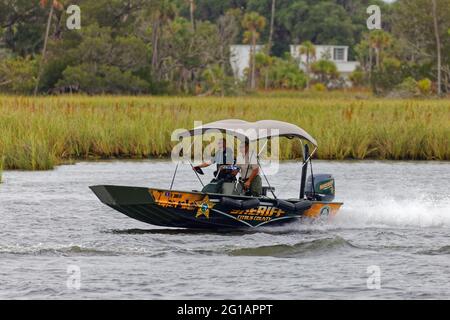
[242,12,266,90]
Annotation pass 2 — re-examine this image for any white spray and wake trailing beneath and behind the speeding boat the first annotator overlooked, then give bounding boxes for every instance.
[106,199,450,236]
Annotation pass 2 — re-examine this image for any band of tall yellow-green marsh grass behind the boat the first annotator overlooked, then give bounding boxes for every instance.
[0,94,450,172]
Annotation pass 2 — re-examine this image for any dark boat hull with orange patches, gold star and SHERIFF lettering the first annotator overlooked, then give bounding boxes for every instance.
[90,186,341,229]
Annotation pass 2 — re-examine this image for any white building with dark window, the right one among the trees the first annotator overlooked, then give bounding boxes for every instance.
[291,45,359,78]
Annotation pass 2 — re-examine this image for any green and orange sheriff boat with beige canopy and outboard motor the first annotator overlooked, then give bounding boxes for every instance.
[90,119,343,230]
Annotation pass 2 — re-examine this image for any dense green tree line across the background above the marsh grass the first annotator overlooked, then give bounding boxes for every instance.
[0,0,450,96]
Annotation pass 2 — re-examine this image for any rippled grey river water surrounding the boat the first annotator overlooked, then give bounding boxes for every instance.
[0,161,450,299]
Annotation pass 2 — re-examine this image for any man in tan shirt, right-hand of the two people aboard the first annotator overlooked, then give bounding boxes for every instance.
[236,140,262,197]
